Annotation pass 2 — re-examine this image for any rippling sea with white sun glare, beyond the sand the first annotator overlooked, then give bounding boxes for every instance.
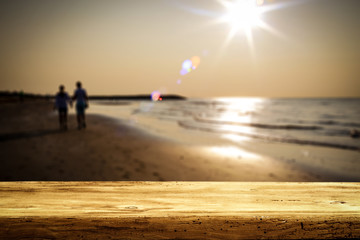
[90,97,360,151]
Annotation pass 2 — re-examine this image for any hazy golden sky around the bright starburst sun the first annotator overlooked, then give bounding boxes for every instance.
[0,0,360,97]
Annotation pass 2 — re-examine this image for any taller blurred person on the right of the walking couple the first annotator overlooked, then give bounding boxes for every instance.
[72,82,89,130]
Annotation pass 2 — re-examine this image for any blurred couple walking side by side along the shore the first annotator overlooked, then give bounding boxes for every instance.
[54,82,88,130]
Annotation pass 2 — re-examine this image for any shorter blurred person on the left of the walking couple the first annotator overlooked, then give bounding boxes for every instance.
[54,85,72,130]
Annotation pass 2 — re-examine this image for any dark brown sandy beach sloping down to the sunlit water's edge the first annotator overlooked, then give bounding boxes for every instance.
[0,100,358,181]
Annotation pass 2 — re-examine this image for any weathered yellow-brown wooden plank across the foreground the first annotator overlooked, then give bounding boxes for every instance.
[0,182,360,239]
